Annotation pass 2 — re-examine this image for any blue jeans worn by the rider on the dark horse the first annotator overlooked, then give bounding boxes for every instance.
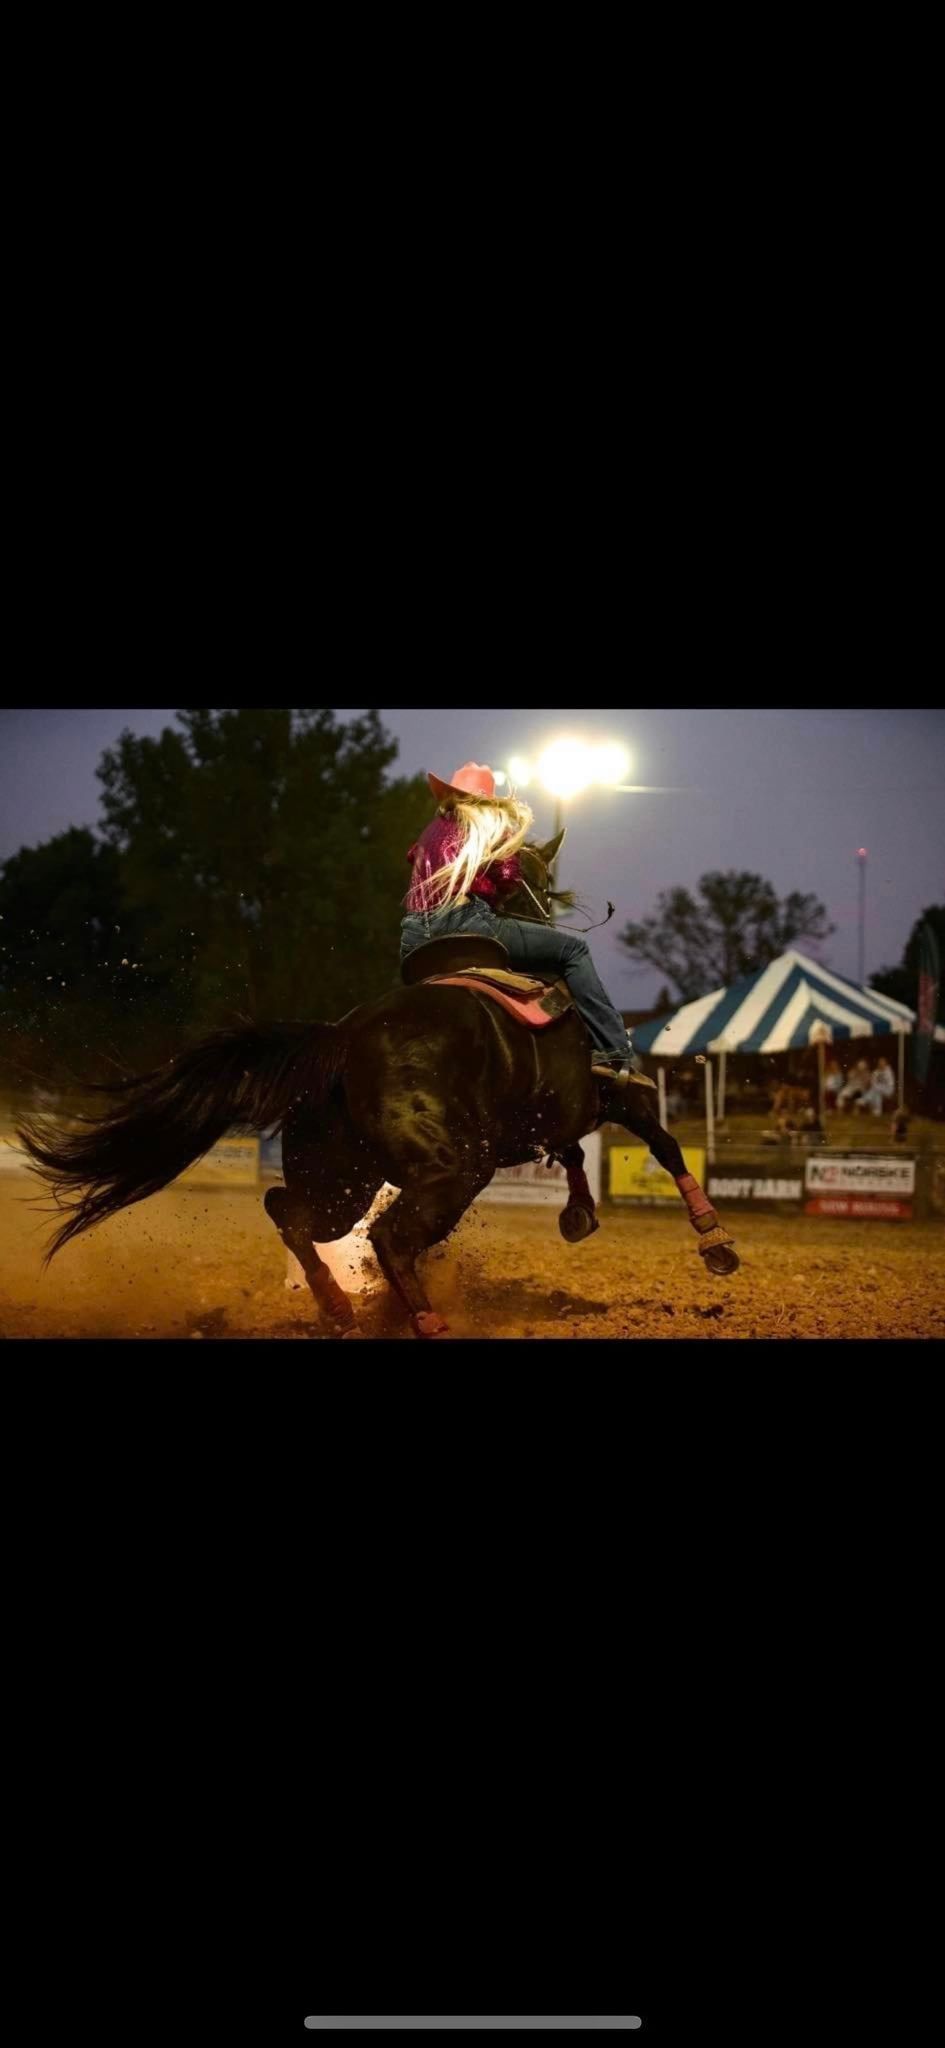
[400,897,629,1059]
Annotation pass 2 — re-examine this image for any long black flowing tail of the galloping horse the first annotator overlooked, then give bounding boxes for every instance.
[16,1024,346,1264]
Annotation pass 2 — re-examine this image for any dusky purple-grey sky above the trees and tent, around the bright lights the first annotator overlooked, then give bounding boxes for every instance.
[0,709,945,1010]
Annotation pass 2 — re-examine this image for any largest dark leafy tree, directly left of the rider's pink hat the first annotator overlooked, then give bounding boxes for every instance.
[98,709,430,1024]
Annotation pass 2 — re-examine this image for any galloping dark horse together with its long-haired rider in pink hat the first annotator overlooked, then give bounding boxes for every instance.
[20,764,738,1337]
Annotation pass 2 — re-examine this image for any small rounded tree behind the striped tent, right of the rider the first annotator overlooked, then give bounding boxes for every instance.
[619,868,834,1001]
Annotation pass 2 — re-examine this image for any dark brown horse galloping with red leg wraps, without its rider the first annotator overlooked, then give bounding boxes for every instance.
[20,840,738,1337]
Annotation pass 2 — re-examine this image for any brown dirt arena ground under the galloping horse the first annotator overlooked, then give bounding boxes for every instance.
[0,1171,945,1339]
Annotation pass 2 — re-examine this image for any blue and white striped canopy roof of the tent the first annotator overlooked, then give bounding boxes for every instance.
[633,952,926,1059]
